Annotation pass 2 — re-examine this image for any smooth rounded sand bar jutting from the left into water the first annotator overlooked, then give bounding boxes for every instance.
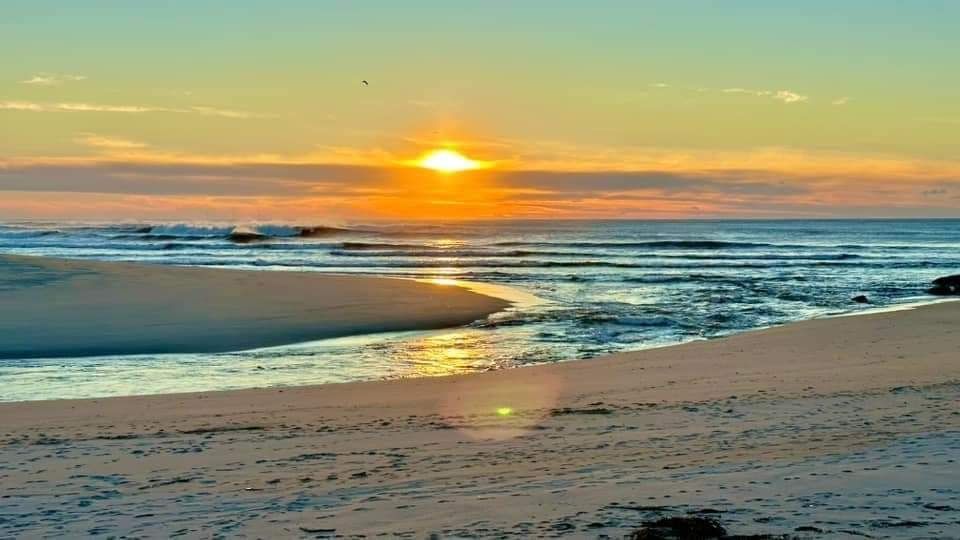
[0,256,508,358]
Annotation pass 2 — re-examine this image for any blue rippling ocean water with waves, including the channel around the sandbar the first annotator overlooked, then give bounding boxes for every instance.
[0,220,960,401]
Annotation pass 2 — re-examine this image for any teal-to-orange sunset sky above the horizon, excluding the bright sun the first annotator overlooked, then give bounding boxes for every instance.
[0,0,960,219]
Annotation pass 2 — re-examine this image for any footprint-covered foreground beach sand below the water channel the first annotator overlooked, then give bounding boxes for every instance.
[0,286,960,538]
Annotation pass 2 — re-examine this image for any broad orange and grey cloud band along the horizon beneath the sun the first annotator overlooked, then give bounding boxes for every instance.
[0,146,960,219]
